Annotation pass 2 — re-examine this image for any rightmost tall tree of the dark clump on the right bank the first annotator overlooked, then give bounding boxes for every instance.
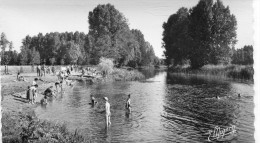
[210,0,237,64]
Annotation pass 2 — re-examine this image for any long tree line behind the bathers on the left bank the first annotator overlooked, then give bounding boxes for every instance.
[2,4,160,67]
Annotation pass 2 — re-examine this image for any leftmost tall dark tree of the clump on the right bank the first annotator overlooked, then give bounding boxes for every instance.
[162,7,190,65]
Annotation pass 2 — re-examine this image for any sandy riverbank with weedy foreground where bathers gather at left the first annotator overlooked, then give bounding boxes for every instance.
[1,73,87,142]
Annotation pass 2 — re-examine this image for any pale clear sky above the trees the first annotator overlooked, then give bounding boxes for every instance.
[0,0,254,58]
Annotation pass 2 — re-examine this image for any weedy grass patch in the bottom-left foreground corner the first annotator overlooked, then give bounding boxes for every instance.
[2,112,89,143]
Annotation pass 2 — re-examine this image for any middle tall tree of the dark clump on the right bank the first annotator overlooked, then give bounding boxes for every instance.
[189,0,213,68]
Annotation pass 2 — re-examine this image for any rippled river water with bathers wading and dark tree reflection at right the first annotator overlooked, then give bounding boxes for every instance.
[36,71,254,143]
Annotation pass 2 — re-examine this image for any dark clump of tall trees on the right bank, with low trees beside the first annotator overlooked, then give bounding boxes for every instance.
[162,0,253,69]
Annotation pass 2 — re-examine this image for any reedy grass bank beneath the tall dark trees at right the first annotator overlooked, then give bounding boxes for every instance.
[169,65,254,81]
